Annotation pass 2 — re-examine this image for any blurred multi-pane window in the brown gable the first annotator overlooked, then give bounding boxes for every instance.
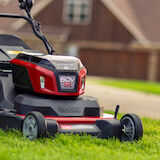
[63,0,92,25]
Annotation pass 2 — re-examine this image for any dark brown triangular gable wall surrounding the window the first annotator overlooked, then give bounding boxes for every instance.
[35,0,134,43]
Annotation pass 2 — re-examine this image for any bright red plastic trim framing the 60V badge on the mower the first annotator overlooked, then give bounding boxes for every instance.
[11,59,87,96]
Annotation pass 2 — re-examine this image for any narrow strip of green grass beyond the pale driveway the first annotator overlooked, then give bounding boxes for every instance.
[88,77,160,94]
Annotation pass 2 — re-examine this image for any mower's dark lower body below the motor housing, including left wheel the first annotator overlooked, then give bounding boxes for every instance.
[0,72,142,139]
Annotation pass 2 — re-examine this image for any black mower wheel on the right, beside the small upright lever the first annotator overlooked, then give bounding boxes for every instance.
[120,114,143,141]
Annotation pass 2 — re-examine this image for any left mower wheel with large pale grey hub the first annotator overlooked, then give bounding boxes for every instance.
[22,112,46,140]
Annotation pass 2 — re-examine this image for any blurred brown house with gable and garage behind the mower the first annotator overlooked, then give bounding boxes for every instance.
[0,0,160,81]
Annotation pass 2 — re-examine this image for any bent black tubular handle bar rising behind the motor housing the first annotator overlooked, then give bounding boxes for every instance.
[0,14,55,55]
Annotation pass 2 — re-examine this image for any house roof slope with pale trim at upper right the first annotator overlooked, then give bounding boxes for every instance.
[101,0,160,44]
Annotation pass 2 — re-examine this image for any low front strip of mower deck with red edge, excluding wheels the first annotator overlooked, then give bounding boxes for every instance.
[0,110,122,138]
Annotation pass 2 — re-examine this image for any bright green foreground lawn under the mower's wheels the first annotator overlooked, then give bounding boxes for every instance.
[0,112,160,160]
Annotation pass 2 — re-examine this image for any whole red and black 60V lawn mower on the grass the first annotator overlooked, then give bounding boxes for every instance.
[0,0,143,141]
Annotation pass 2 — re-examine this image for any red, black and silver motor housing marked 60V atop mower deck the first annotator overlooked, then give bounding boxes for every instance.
[10,53,87,96]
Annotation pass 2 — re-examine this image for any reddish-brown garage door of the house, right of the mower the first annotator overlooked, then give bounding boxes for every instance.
[79,49,149,80]
